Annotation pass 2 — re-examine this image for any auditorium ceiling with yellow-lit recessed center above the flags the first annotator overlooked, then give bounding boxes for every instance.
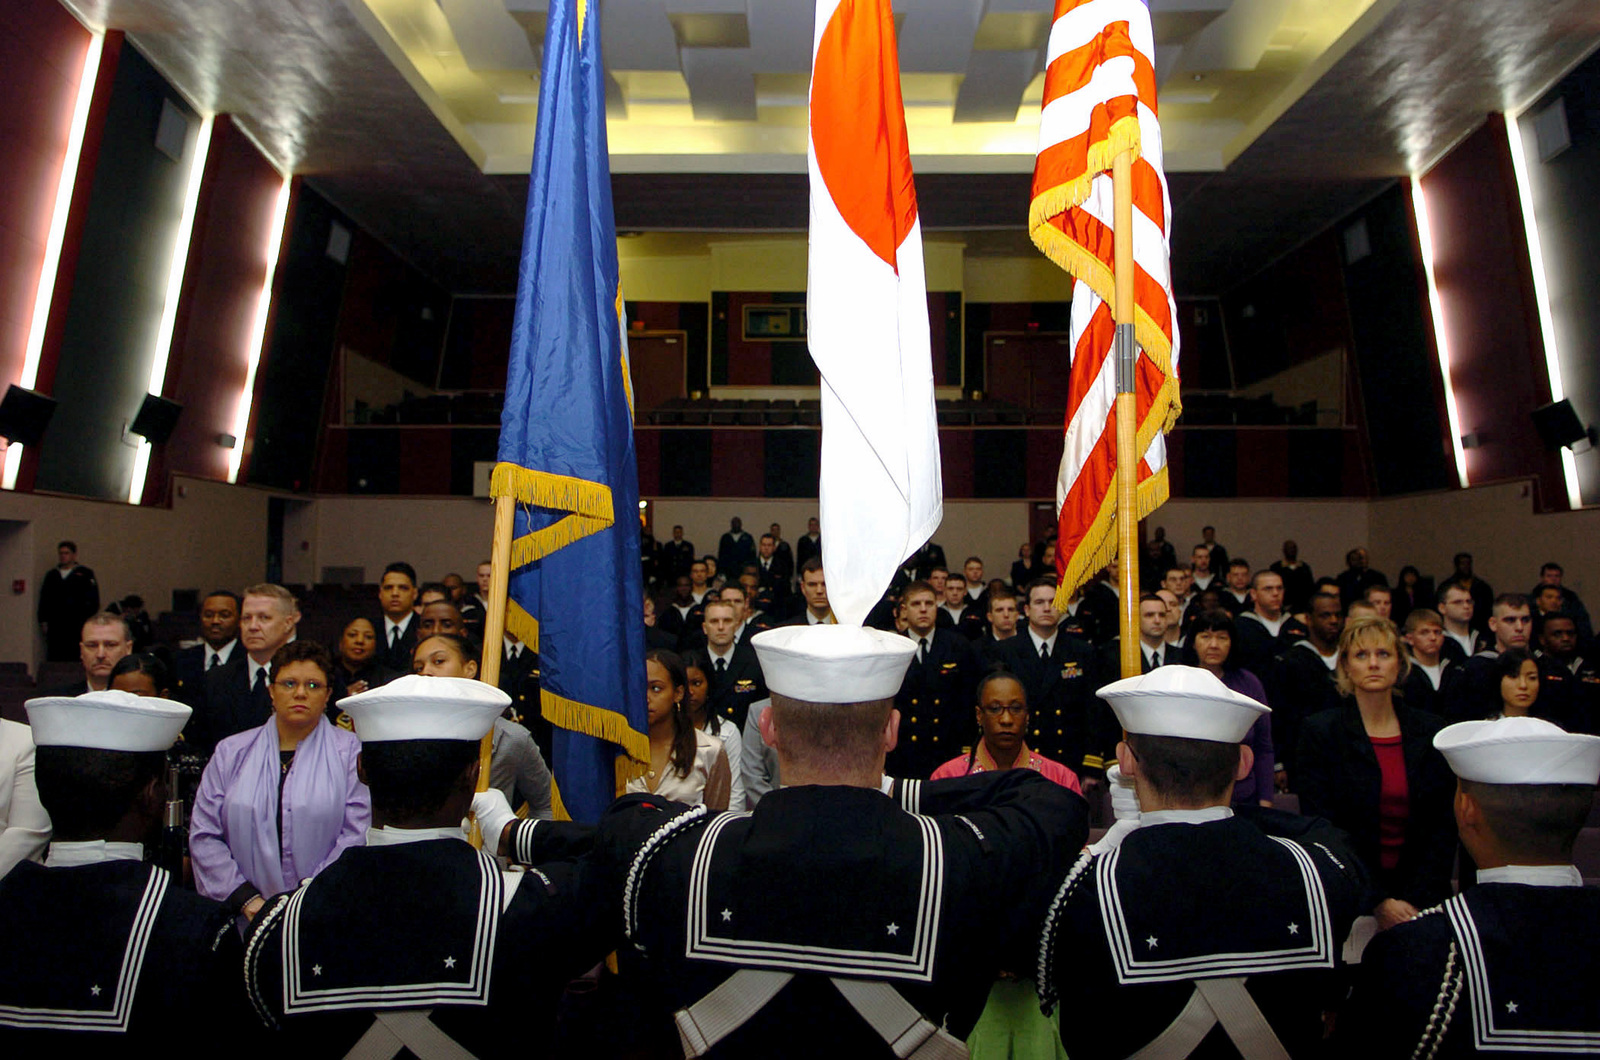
[70,0,1600,293]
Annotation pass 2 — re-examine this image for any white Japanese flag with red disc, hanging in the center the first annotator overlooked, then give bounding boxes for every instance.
[806,0,944,624]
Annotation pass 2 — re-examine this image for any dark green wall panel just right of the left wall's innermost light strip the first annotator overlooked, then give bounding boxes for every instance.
[248,183,347,492]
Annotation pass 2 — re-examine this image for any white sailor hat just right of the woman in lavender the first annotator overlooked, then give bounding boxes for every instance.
[339,674,510,743]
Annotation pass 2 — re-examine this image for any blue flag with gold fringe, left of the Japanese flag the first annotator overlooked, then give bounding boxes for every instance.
[491,0,650,821]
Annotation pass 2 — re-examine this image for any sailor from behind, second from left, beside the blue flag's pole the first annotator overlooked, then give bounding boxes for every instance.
[245,674,605,1057]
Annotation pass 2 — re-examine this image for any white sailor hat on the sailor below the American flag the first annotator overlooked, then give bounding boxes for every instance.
[1099,666,1272,743]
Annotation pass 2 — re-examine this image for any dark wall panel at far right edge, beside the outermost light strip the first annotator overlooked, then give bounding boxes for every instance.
[1520,51,1600,504]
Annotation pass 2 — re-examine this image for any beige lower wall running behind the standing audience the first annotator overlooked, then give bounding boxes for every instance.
[0,479,1600,672]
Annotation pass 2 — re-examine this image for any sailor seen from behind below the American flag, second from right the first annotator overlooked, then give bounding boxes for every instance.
[1037,666,1366,1060]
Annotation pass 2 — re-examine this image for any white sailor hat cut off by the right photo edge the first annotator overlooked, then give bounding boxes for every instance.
[1434,717,1600,785]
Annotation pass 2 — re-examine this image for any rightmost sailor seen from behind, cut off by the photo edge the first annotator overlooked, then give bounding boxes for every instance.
[1339,717,1600,1058]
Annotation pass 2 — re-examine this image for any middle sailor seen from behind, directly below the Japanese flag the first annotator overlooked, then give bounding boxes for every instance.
[486,624,1086,1058]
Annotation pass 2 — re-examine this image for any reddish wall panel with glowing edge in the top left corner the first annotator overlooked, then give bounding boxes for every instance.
[0,0,90,397]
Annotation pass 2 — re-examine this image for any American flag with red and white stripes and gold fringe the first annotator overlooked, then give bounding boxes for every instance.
[1027,0,1181,607]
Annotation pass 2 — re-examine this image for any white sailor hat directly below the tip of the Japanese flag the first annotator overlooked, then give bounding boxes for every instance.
[750,624,917,703]
